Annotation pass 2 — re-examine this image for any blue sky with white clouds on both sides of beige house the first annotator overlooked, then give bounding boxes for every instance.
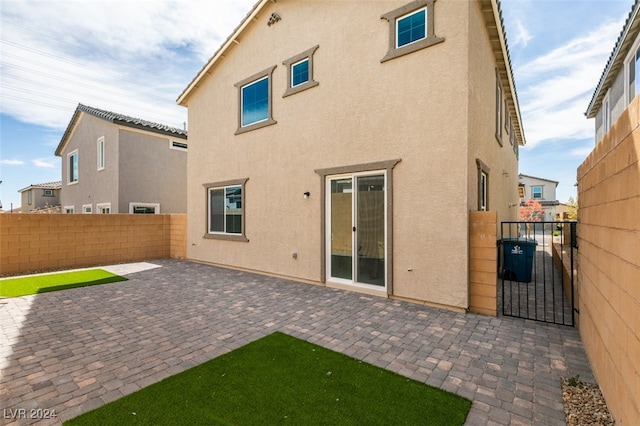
[0,0,633,210]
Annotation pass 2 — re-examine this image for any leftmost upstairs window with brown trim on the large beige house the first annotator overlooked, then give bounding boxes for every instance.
[235,65,276,135]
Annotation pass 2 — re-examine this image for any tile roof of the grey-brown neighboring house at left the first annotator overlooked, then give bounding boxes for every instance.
[55,104,188,155]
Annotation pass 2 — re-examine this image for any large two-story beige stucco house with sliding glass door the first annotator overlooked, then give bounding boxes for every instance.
[178,0,525,310]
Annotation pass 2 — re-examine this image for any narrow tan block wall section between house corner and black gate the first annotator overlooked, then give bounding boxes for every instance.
[469,211,498,317]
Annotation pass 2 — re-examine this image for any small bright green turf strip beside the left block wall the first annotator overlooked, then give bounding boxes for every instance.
[0,269,127,297]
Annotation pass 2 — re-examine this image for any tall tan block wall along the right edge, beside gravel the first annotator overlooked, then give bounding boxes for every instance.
[578,97,640,425]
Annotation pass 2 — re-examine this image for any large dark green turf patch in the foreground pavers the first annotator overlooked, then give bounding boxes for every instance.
[64,332,471,426]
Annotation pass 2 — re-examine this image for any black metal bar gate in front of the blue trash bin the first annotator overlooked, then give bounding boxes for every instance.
[498,222,578,326]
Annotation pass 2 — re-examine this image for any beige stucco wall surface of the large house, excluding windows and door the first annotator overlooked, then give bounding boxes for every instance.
[187,1,516,309]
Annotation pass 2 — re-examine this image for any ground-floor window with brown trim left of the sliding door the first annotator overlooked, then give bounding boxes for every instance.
[204,179,248,241]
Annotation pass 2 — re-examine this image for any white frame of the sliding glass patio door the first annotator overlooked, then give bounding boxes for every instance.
[324,169,390,292]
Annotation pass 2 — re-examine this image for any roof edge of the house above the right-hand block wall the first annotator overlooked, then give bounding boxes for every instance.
[584,0,640,118]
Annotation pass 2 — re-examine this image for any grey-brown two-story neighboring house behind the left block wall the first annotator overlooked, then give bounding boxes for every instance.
[55,104,187,213]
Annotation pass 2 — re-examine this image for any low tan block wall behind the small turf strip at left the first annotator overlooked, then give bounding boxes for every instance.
[0,213,187,276]
